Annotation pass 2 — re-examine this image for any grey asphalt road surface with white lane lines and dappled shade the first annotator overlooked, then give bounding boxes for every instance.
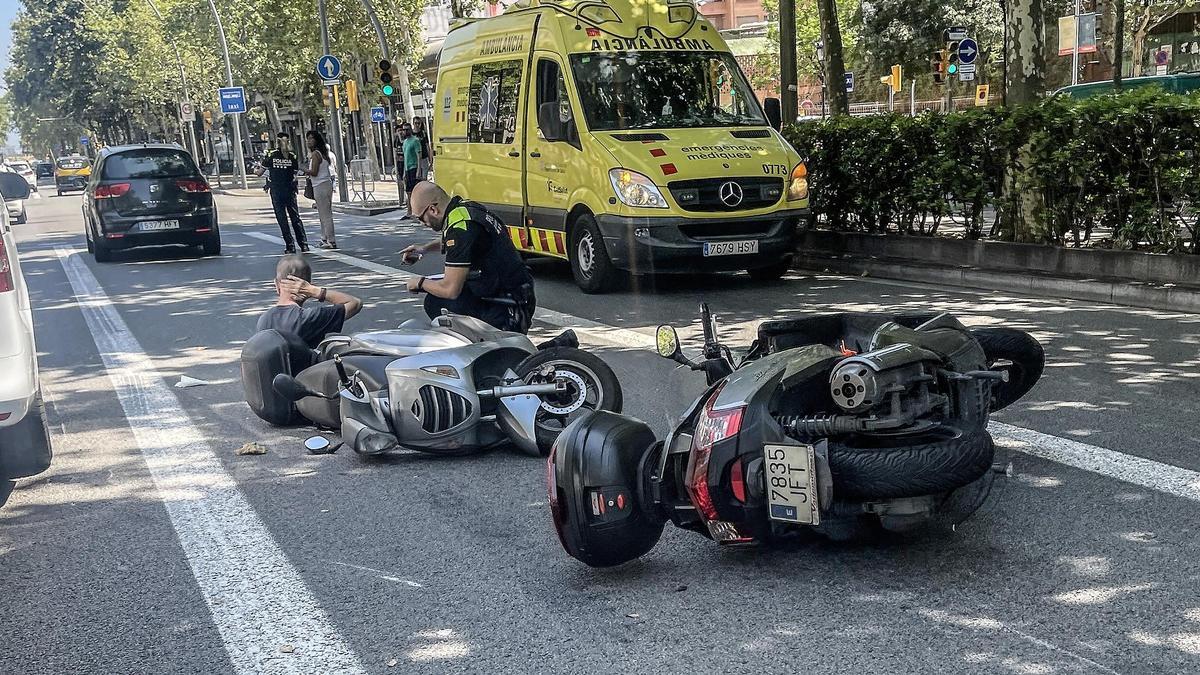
[0,187,1200,674]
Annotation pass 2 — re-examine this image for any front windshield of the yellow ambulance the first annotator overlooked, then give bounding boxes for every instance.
[571,50,767,131]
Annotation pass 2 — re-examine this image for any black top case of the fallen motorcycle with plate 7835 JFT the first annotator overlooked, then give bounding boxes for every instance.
[547,411,665,567]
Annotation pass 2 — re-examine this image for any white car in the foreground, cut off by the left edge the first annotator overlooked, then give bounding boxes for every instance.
[0,172,50,480]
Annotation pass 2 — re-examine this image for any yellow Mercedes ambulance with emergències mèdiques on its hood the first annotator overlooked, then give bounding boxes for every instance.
[432,0,809,293]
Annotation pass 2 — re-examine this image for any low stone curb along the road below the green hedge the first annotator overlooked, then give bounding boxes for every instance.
[793,251,1200,313]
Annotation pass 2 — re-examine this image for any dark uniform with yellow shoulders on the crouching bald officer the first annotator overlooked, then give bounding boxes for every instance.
[425,197,536,333]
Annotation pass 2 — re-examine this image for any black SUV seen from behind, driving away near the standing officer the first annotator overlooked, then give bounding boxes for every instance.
[83,144,221,262]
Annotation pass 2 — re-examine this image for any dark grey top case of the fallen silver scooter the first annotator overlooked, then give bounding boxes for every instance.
[241,330,316,426]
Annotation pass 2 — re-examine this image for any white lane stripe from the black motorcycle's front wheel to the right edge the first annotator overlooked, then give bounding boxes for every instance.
[991,422,1200,502]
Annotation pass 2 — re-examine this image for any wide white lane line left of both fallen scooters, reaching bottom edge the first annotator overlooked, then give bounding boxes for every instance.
[58,247,364,674]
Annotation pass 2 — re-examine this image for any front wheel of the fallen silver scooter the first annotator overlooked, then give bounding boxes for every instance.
[516,347,623,456]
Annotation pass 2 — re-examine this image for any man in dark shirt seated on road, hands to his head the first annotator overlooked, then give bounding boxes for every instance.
[258,253,362,348]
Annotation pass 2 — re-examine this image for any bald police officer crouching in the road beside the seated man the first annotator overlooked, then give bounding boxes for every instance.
[401,180,536,333]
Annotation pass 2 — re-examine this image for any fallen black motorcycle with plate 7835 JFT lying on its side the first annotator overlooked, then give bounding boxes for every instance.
[547,305,1044,567]
